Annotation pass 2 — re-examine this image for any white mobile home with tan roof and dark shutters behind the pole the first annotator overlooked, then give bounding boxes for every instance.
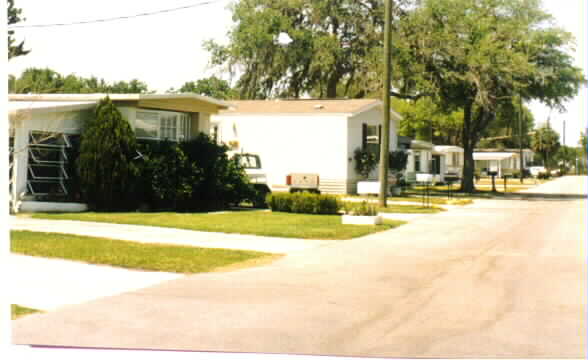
[211,99,401,194]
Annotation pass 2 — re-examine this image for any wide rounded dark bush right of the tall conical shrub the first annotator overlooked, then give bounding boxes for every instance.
[135,134,254,211]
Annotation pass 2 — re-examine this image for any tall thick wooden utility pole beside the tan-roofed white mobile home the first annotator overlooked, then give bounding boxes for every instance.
[378,0,392,207]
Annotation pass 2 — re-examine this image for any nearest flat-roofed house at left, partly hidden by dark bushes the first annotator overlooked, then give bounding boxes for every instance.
[8,94,227,212]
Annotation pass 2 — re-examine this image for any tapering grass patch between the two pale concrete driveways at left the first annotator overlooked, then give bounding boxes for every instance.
[10,231,276,273]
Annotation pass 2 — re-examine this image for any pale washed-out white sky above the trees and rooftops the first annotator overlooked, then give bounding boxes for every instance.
[8,0,588,146]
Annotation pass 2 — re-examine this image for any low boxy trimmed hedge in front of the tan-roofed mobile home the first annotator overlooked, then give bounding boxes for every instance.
[266,192,341,215]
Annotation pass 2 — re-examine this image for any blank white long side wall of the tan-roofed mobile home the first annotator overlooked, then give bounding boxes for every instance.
[212,114,347,190]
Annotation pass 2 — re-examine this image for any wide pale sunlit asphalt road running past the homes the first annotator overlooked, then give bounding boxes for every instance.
[12,177,588,358]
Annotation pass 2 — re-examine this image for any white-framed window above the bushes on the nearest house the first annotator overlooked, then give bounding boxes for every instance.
[135,110,191,141]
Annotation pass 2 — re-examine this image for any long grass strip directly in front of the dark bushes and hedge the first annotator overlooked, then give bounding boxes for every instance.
[32,211,404,240]
